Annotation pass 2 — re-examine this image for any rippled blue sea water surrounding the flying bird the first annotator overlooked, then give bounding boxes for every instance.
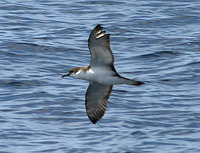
[0,0,200,153]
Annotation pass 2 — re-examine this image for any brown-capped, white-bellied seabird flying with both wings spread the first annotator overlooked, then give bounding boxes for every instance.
[62,24,144,124]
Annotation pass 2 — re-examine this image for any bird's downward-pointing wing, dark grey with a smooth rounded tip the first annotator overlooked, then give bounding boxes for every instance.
[85,82,113,124]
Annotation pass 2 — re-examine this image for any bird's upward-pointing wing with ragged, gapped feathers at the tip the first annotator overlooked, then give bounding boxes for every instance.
[88,24,114,67]
